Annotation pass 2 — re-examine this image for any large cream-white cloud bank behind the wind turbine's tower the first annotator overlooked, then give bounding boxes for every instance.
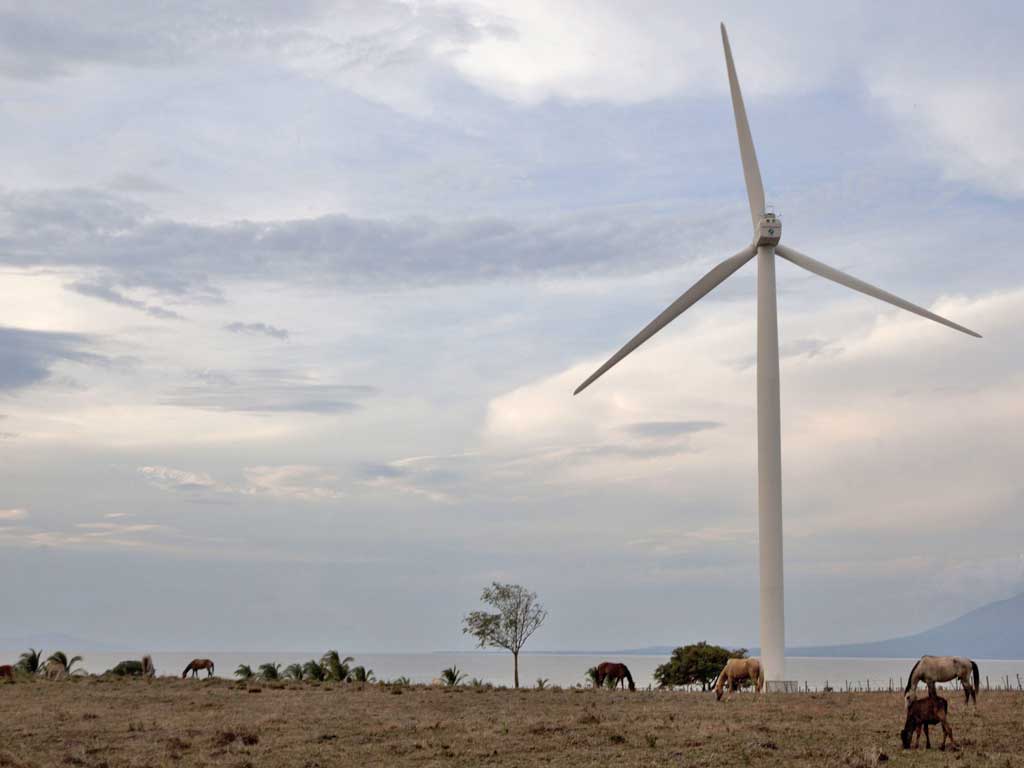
[484,284,1024,546]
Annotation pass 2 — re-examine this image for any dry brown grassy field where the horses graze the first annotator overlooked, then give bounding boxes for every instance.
[0,678,1024,768]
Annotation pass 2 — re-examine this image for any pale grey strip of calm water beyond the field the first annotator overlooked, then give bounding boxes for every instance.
[9,651,1024,689]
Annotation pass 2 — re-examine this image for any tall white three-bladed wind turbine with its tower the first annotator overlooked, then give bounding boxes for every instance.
[573,24,981,681]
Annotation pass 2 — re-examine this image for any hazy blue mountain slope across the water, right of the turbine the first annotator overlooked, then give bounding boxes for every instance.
[785,594,1024,658]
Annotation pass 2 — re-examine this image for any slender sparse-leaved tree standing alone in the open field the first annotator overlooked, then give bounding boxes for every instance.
[462,582,548,688]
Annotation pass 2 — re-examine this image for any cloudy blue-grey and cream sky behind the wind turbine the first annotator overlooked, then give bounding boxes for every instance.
[0,0,1024,651]
